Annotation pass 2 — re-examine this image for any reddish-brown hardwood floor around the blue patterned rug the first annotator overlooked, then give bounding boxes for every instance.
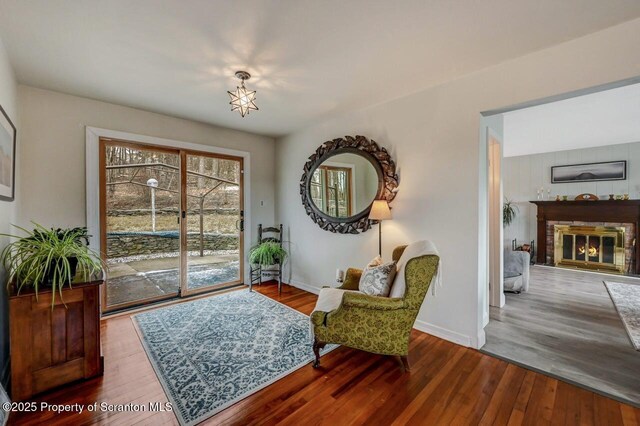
[10,285,640,426]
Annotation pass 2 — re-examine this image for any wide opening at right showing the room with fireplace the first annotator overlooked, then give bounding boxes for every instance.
[479,79,640,406]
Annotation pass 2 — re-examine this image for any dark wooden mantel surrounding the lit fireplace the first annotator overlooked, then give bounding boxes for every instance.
[531,200,640,274]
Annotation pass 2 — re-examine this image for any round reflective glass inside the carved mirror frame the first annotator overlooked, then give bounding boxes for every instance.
[310,153,378,218]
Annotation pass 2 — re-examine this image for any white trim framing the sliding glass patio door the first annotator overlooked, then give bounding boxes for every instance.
[86,126,253,283]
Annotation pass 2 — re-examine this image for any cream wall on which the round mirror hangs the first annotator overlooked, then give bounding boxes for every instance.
[276,20,640,347]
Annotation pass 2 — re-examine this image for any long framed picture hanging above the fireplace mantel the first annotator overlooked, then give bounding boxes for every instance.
[551,161,627,183]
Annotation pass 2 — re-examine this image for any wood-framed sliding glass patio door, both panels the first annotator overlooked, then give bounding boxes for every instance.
[100,139,244,312]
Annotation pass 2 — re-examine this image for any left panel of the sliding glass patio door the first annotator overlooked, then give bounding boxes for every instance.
[101,140,181,311]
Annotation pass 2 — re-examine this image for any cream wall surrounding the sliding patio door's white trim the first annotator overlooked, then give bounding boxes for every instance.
[18,85,275,258]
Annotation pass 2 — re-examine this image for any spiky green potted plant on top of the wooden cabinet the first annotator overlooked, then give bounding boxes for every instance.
[0,222,103,306]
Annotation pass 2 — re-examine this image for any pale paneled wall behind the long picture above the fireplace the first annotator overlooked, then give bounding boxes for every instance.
[502,140,640,245]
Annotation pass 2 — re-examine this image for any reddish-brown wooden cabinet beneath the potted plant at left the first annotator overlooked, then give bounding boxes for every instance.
[9,281,103,401]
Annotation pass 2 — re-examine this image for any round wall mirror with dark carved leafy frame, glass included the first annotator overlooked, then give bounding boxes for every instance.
[300,136,398,234]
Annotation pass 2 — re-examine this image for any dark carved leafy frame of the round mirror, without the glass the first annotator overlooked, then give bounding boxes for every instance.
[300,136,398,234]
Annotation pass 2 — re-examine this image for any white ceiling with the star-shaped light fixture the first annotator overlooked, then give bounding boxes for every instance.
[0,0,640,135]
